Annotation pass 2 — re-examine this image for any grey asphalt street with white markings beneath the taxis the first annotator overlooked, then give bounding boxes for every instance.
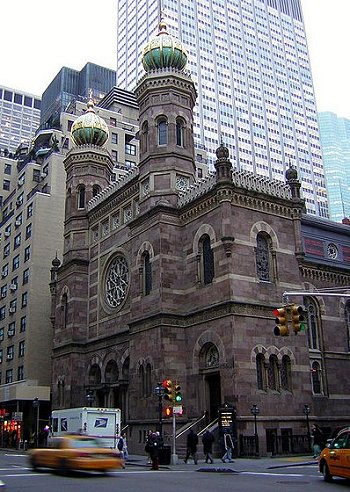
[0,452,349,492]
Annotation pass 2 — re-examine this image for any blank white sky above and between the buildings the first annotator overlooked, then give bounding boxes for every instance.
[0,0,350,119]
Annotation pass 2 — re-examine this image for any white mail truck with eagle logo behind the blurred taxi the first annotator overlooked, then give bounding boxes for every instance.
[49,407,121,449]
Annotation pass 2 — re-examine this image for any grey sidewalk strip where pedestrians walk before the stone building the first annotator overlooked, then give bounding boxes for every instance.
[126,454,318,472]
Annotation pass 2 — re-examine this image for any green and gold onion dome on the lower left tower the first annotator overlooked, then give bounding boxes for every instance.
[71,99,109,147]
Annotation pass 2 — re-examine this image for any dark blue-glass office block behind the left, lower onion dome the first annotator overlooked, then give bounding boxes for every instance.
[40,63,116,128]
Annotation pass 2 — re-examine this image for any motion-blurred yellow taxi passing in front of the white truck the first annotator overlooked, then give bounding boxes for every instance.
[29,434,124,473]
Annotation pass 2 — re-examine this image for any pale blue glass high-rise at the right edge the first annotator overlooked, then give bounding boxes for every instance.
[318,112,350,222]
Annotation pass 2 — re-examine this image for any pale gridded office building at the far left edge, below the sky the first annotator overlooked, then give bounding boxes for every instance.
[0,86,41,155]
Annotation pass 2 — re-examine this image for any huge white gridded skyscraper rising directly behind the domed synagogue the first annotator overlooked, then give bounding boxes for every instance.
[117,0,328,217]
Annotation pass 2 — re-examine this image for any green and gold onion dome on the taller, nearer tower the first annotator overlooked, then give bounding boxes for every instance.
[142,21,188,72]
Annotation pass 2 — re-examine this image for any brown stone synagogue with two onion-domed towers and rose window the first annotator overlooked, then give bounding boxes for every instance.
[51,25,350,454]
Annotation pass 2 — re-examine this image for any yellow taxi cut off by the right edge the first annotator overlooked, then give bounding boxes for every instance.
[319,427,350,482]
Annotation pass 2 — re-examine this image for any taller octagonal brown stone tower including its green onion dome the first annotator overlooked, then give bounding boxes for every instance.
[135,22,196,208]
